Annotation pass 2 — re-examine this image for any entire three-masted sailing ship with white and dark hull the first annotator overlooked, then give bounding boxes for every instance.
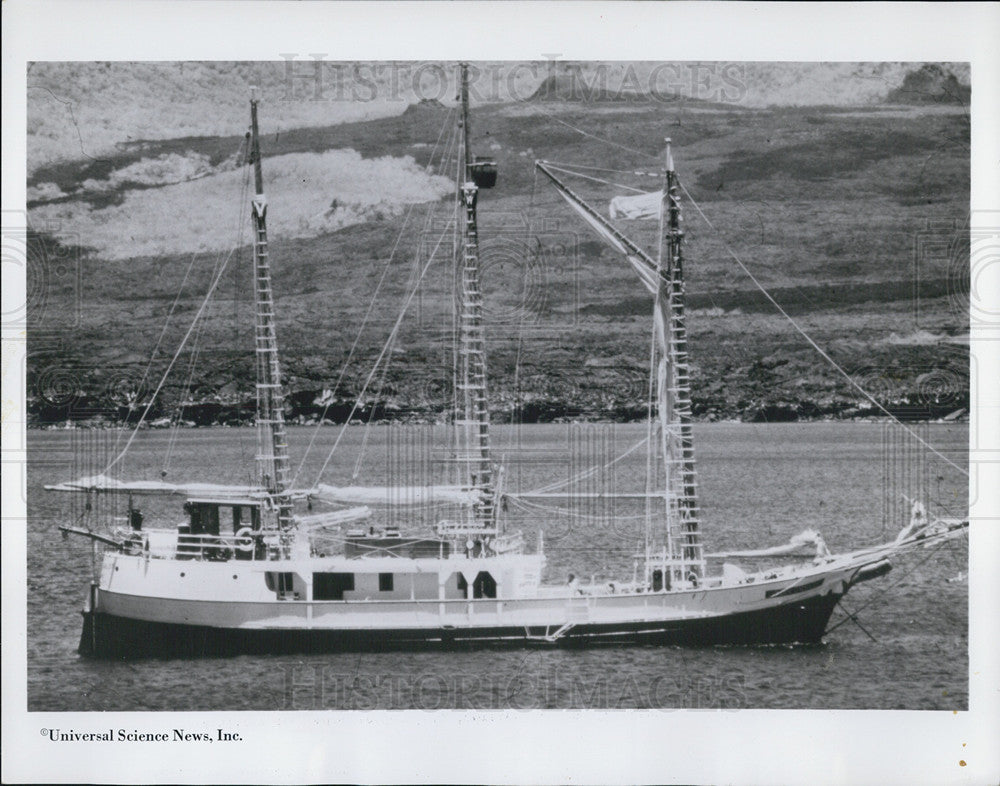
[47,66,968,657]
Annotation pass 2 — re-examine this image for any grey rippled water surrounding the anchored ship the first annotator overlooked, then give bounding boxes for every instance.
[27,423,968,710]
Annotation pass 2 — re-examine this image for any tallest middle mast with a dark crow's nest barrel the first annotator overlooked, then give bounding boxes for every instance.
[456,63,496,530]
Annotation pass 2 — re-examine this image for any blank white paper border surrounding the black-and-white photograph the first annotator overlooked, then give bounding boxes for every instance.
[2,0,1000,784]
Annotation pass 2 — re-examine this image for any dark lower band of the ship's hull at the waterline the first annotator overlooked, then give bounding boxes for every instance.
[80,593,840,659]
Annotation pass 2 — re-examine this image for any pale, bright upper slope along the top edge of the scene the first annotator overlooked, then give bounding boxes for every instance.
[27,60,969,175]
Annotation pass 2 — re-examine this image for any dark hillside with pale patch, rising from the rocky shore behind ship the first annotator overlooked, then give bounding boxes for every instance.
[28,64,969,424]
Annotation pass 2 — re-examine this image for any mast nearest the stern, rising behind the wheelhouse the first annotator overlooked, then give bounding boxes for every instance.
[250,88,292,530]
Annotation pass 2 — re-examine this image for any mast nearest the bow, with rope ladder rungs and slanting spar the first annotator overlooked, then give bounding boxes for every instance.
[655,139,704,580]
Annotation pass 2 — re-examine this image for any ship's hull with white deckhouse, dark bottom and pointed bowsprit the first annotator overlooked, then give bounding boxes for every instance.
[72,521,965,657]
